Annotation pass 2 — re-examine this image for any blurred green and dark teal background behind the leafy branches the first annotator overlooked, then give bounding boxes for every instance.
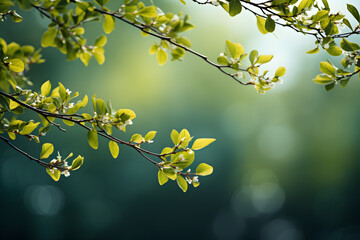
[0,0,360,240]
